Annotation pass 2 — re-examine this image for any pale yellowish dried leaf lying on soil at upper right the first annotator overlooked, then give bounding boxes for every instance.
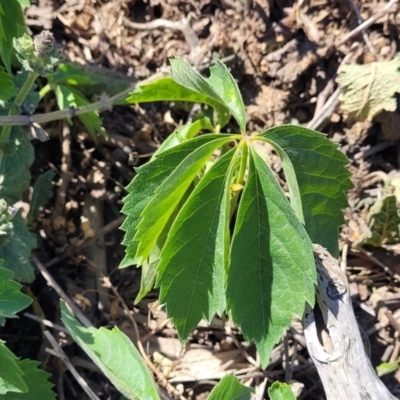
[336,54,400,121]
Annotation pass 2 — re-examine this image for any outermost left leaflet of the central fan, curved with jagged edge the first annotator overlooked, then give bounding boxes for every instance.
[120,134,231,268]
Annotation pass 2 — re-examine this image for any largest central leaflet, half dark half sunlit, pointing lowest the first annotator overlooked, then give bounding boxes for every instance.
[226,147,316,366]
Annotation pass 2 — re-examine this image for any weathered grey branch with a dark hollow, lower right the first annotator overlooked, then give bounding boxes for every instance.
[304,245,396,400]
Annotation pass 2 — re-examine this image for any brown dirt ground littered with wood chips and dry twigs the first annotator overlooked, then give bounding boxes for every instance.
[0,0,400,400]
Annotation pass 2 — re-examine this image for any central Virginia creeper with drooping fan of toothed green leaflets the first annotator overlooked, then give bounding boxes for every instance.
[121,59,351,367]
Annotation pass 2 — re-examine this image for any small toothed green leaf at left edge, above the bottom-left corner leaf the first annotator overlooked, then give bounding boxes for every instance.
[0,260,32,318]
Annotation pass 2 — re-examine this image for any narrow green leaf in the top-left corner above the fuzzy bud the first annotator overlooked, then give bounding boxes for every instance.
[0,0,25,74]
